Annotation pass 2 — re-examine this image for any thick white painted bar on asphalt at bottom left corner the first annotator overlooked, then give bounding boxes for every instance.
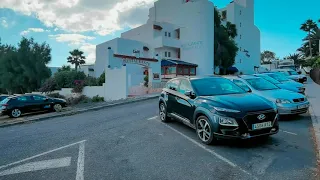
[0,157,71,176]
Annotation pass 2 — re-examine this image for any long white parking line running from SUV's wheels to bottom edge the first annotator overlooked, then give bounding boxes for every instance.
[164,124,258,180]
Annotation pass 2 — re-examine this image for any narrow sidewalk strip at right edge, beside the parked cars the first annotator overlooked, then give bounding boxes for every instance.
[305,77,320,158]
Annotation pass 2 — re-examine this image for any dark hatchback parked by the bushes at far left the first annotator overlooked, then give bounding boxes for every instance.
[0,94,67,118]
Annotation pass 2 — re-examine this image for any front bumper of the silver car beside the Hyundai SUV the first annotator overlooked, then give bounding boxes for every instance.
[278,102,310,115]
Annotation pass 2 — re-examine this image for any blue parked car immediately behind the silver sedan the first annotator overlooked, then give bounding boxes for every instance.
[254,74,306,94]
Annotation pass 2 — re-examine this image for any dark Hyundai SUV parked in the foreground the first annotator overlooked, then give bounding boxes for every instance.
[159,77,279,144]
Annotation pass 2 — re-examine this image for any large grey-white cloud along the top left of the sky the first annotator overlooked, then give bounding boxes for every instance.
[0,0,155,35]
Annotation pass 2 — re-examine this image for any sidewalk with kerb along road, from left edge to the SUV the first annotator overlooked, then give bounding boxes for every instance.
[0,93,159,127]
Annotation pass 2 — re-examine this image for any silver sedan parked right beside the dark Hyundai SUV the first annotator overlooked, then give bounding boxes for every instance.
[225,75,309,115]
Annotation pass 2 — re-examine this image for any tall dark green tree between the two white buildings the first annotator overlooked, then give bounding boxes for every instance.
[214,9,239,74]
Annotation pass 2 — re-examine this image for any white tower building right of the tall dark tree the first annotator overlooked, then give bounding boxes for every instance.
[220,0,261,74]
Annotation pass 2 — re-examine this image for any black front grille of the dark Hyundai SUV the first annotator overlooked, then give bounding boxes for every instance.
[243,109,277,130]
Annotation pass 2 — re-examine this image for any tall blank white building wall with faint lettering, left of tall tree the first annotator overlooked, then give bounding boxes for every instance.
[148,0,214,75]
